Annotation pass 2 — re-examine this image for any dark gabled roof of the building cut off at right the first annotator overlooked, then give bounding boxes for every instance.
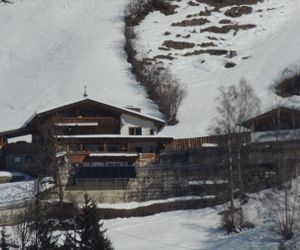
[240,106,300,129]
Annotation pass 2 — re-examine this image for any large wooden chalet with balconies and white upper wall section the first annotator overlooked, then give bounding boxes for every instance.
[0,98,172,186]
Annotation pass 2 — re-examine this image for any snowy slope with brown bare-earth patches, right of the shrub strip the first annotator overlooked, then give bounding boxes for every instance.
[136,0,300,137]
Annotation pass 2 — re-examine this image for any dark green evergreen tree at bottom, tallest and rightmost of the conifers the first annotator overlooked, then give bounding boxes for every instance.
[75,194,113,250]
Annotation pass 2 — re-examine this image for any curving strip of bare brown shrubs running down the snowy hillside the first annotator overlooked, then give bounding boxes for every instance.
[124,0,185,125]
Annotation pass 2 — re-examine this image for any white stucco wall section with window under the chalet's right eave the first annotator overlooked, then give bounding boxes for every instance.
[121,114,157,135]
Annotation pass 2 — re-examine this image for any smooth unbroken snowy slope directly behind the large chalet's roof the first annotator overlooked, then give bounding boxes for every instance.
[0,0,160,132]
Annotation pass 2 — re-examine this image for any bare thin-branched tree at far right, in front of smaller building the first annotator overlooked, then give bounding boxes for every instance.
[267,100,300,249]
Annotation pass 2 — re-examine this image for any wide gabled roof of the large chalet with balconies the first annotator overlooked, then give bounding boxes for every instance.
[22,98,165,128]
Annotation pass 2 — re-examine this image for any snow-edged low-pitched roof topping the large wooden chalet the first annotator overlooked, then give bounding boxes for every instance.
[22,98,165,128]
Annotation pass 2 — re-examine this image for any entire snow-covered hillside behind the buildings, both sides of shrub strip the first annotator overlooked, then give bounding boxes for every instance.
[0,0,300,137]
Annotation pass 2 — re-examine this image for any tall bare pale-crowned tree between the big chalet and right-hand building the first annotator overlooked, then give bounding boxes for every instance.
[209,79,260,231]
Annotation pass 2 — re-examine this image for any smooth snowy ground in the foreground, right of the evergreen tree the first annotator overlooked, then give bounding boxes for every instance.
[104,208,278,250]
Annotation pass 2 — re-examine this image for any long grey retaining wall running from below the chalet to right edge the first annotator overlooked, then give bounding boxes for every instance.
[63,143,300,203]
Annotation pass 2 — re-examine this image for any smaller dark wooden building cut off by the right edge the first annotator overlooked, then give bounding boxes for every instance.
[240,107,300,142]
